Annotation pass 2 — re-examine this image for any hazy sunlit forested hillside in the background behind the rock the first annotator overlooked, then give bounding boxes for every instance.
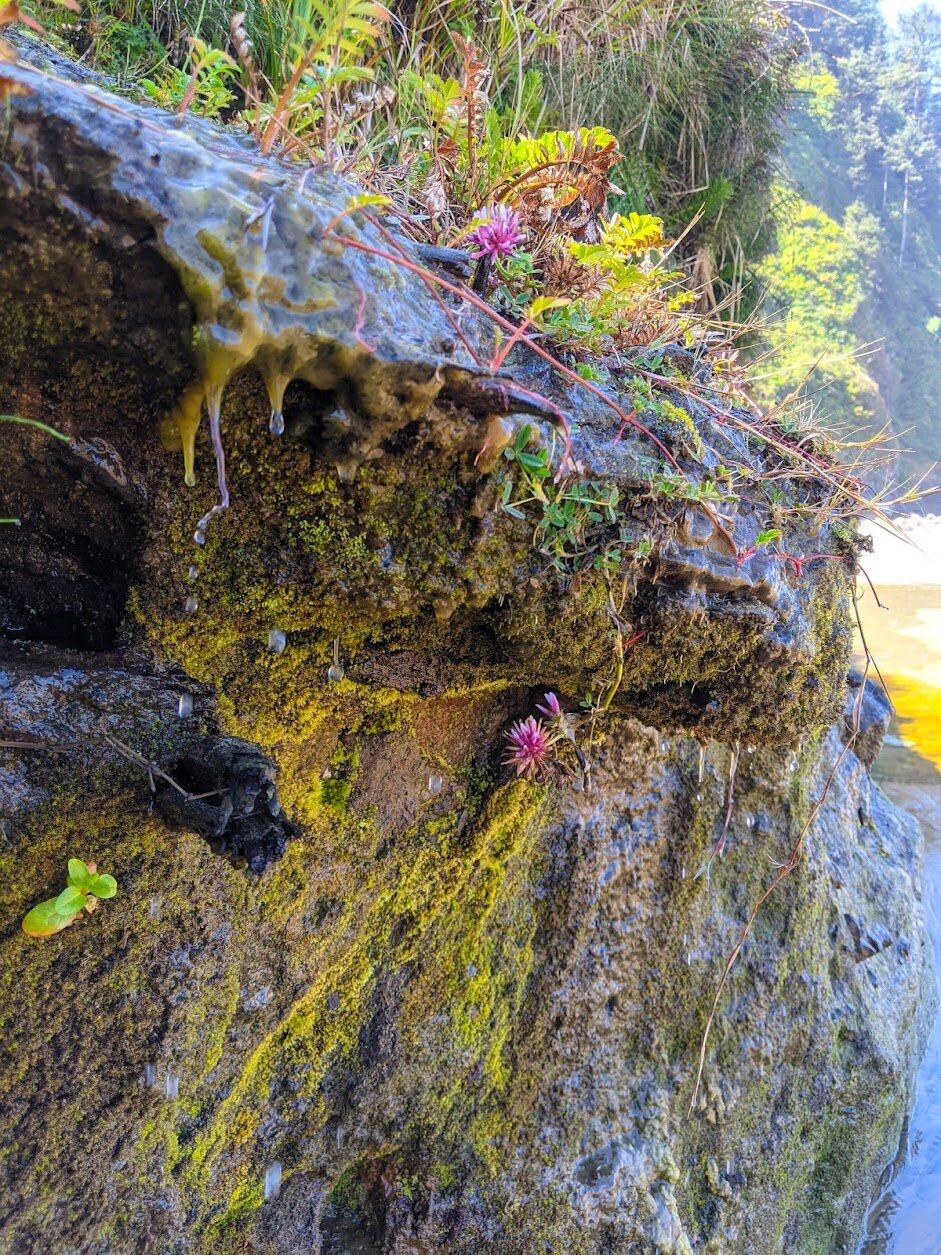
[755,0,941,499]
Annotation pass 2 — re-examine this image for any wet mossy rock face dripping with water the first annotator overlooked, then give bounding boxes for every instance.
[0,48,933,1255]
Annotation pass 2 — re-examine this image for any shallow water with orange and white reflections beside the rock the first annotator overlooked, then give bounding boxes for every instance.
[859,518,941,1255]
